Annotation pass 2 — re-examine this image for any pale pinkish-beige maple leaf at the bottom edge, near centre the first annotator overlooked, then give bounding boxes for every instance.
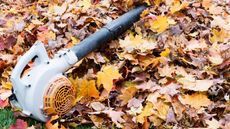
[103,109,125,128]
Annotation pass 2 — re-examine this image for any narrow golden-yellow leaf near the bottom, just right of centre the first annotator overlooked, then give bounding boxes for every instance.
[136,102,153,124]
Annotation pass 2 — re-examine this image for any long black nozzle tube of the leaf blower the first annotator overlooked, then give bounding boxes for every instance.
[71,5,147,60]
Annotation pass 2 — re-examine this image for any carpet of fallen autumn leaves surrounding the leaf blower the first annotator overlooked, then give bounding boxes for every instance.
[0,0,230,129]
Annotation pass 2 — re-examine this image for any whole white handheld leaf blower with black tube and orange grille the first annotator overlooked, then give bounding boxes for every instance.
[11,5,146,122]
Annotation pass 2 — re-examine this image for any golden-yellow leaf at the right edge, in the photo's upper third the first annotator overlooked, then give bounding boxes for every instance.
[209,28,228,43]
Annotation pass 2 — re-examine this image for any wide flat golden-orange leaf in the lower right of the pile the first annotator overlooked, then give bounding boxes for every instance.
[179,93,212,109]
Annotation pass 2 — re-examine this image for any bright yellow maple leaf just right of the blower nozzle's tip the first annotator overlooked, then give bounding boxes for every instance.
[150,16,169,33]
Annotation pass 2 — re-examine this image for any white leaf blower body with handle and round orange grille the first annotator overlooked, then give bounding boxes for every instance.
[11,42,78,121]
